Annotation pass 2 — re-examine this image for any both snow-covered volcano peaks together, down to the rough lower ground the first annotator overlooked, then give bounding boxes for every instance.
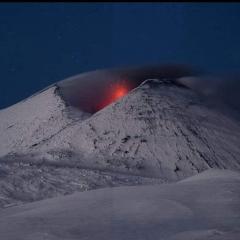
[0,76,240,175]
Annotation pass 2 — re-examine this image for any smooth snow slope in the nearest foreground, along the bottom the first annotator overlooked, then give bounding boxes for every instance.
[0,170,240,240]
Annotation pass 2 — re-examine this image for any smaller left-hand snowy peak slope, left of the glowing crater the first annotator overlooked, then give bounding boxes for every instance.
[0,86,88,156]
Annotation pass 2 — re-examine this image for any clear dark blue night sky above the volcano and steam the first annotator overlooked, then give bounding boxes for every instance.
[0,3,240,108]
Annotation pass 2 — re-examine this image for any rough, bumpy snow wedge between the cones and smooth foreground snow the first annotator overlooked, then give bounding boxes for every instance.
[0,159,163,209]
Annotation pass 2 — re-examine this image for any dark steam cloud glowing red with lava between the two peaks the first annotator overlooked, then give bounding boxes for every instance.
[57,65,195,113]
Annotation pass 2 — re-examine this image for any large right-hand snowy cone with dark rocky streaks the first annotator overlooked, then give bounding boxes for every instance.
[19,80,240,180]
